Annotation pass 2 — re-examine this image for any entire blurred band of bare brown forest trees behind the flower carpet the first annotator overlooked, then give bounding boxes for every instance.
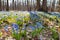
[0,0,60,12]
